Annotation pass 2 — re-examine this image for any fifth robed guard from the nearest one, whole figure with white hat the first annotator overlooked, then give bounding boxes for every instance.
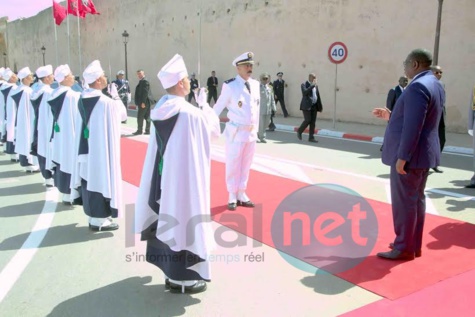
[11,67,39,172]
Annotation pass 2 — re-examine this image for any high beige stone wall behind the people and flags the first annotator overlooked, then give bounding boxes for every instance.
[0,0,475,132]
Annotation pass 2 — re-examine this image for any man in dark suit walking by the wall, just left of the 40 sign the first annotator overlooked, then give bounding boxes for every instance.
[297,73,323,143]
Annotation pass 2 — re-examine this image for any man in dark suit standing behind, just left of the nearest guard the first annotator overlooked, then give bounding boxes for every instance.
[133,69,153,135]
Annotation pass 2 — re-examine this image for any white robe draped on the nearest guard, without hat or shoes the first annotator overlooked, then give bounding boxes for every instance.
[135,95,220,280]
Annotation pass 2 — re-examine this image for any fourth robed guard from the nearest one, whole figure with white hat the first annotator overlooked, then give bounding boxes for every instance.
[31,65,54,187]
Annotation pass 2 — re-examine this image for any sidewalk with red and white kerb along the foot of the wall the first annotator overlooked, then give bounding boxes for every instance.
[260,115,474,155]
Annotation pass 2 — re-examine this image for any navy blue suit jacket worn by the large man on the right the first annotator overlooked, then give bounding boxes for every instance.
[382,71,445,168]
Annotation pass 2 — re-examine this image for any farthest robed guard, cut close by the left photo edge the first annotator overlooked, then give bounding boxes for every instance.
[1,68,18,162]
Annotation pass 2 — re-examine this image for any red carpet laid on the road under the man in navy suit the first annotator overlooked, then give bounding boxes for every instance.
[122,138,475,300]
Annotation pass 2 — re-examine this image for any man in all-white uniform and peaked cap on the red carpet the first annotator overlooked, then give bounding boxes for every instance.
[214,52,260,210]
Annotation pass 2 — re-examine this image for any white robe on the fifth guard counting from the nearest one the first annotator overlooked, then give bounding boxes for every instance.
[13,84,34,164]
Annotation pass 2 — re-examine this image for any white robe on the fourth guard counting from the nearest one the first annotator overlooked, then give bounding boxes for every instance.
[31,83,53,161]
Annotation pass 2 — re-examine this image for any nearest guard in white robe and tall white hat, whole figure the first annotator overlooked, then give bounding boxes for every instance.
[135,54,220,293]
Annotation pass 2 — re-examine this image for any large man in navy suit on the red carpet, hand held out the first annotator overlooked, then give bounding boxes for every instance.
[373,49,445,261]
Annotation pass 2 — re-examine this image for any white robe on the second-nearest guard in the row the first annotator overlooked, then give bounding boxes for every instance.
[71,88,127,212]
